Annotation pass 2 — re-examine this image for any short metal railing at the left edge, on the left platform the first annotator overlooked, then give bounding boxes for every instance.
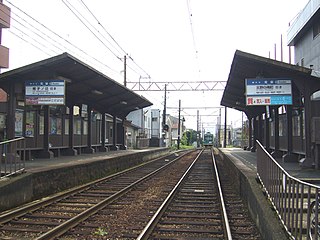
[0,137,26,179]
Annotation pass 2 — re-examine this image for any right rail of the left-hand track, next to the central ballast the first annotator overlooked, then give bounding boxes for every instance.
[36,151,190,240]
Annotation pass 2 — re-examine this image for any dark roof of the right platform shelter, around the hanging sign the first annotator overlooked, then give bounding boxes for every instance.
[221,50,320,117]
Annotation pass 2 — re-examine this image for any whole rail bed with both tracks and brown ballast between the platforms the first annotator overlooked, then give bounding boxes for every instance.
[0,149,260,239]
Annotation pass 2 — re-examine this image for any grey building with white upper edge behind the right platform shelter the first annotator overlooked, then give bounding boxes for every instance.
[287,0,320,167]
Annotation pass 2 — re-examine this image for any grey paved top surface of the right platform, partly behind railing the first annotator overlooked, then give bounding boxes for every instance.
[220,148,320,185]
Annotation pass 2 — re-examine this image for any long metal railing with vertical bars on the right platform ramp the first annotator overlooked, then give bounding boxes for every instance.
[257,141,320,239]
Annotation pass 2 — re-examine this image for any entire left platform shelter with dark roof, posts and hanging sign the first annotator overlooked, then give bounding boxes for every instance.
[0,53,152,159]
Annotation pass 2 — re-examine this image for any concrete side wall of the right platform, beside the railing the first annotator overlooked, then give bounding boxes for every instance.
[219,149,290,240]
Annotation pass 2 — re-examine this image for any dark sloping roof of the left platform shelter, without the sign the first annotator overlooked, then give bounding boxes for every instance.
[0,53,152,118]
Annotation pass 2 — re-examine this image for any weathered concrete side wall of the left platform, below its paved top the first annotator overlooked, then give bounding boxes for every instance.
[0,148,169,212]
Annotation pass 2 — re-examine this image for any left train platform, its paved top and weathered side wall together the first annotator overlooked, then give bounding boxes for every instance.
[0,148,170,212]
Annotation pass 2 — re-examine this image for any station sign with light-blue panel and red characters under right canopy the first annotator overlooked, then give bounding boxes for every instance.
[246,78,292,106]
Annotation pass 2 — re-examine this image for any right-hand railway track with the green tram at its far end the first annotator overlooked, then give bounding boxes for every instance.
[137,149,261,240]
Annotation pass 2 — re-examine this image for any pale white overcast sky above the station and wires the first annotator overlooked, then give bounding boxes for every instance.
[2,0,308,131]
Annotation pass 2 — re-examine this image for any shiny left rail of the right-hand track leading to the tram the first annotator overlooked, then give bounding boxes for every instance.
[137,149,204,240]
